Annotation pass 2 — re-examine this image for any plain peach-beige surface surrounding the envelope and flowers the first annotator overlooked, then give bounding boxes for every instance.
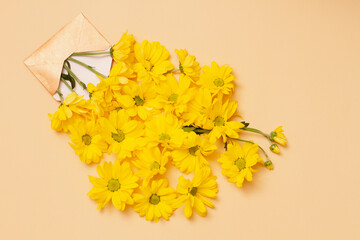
[0,0,360,239]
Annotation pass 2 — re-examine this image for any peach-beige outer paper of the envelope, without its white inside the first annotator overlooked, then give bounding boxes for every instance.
[24,13,111,95]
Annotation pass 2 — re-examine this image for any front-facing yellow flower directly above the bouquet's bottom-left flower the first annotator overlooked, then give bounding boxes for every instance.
[101,109,144,160]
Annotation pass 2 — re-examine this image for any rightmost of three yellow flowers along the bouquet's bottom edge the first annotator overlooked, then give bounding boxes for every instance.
[175,167,218,218]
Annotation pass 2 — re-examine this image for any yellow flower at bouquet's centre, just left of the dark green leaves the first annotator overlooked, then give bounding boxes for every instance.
[145,114,186,149]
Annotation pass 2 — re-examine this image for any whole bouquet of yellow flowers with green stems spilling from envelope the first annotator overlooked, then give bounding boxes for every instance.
[49,32,287,222]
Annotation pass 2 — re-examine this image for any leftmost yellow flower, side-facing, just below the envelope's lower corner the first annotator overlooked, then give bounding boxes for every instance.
[48,92,91,132]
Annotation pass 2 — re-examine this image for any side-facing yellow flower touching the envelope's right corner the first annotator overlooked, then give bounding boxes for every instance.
[110,31,135,63]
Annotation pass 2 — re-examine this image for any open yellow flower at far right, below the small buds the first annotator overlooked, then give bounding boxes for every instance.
[218,142,262,187]
